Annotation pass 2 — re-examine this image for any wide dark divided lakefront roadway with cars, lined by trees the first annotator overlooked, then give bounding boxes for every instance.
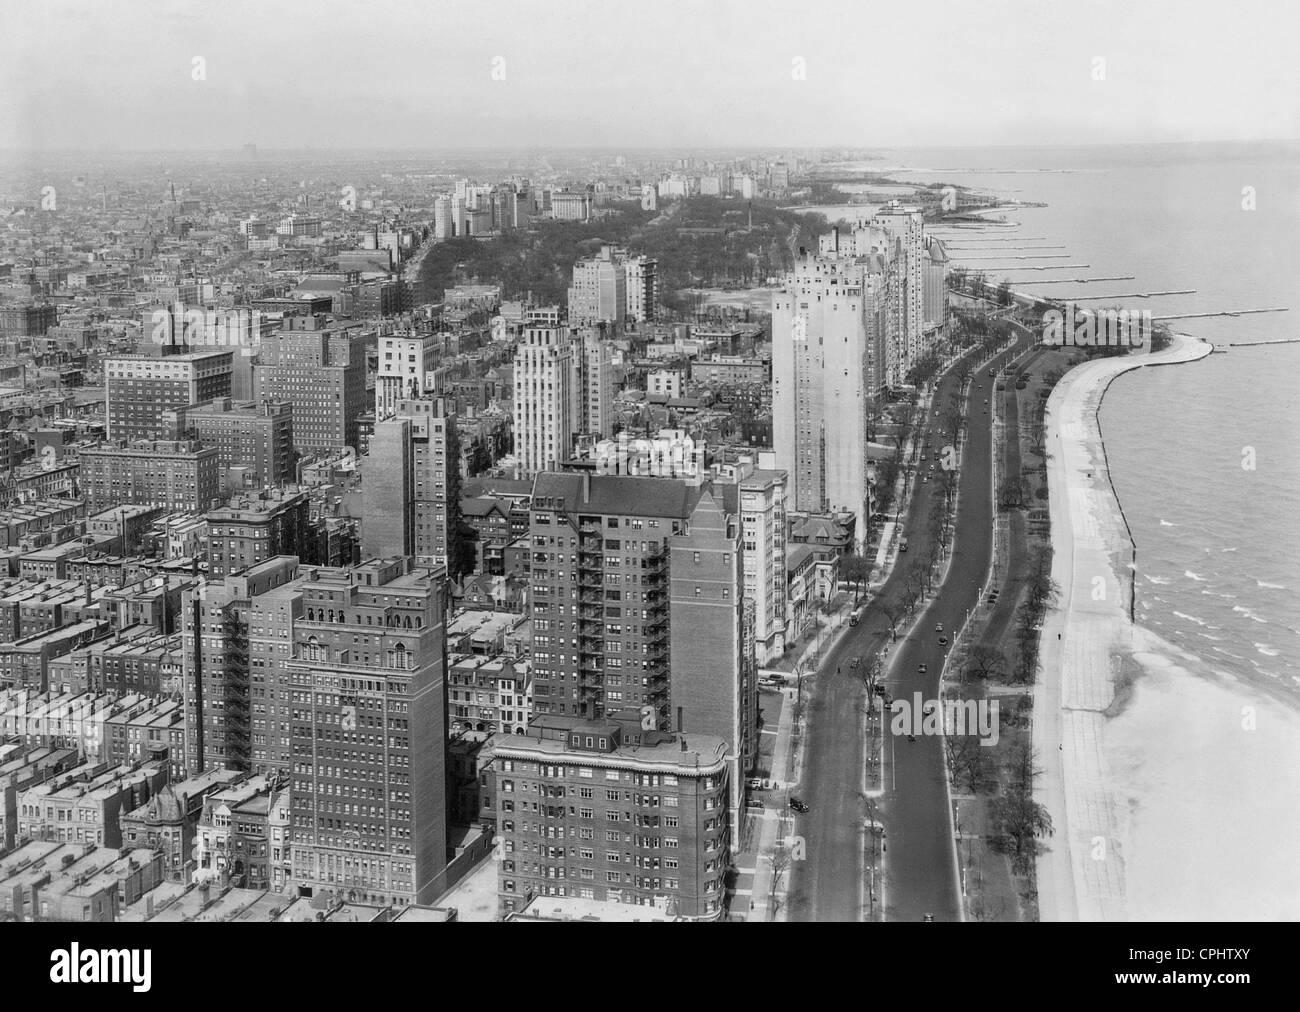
[790,327,1027,921]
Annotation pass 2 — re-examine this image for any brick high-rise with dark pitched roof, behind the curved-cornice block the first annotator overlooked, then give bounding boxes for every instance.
[529,472,755,780]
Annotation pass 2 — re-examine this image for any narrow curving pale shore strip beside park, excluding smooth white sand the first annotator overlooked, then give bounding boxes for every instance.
[1034,334,1210,921]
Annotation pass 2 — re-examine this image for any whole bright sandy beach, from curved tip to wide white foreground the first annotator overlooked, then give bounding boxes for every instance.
[1034,336,1300,921]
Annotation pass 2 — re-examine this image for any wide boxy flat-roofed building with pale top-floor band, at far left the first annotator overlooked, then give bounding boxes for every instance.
[104,349,234,441]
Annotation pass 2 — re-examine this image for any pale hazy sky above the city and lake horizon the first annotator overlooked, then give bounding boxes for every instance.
[0,0,1300,151]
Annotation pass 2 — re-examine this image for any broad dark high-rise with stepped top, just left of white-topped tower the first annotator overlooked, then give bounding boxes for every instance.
[253,316,368,457]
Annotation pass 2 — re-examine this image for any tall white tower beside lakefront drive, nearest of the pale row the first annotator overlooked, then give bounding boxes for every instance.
[772,232,891,531]
